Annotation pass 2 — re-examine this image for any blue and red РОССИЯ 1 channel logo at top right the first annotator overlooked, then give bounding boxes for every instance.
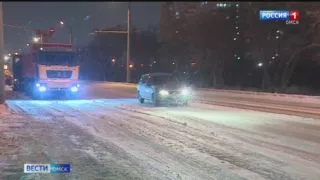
[260,10,300,24]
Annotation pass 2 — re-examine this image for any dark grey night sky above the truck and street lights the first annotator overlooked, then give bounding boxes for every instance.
[3,2,160,53]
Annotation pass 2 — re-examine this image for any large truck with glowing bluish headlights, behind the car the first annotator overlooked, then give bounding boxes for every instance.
[13,43,80,96]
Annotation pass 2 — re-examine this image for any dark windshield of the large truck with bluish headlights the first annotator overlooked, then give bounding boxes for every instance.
[37,52,76,66]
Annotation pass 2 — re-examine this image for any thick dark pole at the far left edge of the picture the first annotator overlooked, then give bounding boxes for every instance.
[0,2,5,104]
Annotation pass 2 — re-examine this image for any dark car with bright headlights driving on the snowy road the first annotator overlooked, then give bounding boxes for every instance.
[137,73,191,106]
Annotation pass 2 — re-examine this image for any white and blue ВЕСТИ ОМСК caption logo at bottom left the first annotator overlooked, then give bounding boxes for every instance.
[24,164,71,173]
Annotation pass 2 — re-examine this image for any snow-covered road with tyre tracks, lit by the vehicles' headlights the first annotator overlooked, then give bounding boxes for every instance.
[0,84,320,180]
